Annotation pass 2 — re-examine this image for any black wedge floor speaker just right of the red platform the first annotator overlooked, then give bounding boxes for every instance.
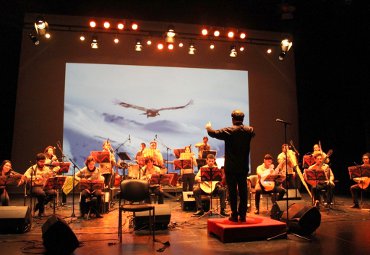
[271,200,321,235]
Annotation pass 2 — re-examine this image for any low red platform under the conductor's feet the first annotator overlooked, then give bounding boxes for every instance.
[207,215,287,243]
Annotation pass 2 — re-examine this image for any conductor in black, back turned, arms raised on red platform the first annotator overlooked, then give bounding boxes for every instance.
[206,110,254,222]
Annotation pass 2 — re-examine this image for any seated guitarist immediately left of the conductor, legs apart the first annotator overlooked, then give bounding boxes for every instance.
[193,154,229,217]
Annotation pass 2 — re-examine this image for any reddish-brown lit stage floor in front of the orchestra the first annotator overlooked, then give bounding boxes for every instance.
[0,194,370,255]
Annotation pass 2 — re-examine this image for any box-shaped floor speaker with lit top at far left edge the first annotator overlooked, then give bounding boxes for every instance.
[0,206,31,233]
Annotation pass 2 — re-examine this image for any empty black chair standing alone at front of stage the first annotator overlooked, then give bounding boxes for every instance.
[118,179,155,243]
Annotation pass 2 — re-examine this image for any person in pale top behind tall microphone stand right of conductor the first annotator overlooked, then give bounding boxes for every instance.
[277,144,297,189]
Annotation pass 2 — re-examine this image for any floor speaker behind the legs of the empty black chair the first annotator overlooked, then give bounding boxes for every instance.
[134,204,171,230]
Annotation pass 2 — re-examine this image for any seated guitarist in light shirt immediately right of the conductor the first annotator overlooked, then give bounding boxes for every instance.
[254,154,285,214]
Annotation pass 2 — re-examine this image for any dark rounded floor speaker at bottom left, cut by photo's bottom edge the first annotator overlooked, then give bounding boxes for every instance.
[42,215,79,254]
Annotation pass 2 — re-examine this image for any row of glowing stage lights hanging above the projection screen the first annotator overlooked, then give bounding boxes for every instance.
[29,17,292,60]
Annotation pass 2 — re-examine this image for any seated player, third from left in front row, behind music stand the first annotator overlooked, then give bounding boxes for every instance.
[75,156,104,218]
